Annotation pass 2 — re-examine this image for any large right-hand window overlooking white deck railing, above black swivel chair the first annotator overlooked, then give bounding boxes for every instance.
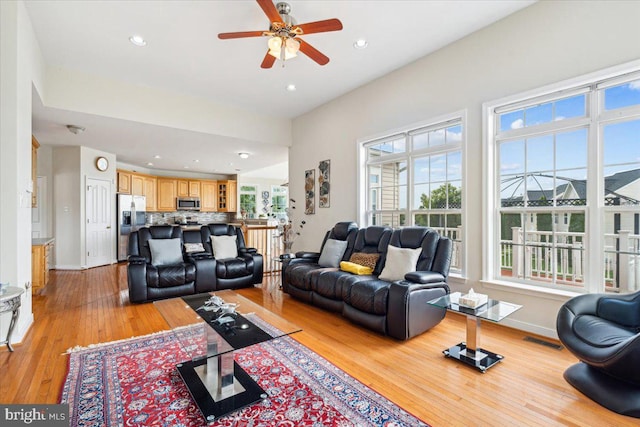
[486,68,640,292]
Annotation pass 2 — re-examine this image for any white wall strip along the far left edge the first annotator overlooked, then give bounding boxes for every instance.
[0,1,43,342]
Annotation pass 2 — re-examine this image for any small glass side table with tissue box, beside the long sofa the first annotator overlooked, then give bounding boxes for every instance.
[427,292,522,373]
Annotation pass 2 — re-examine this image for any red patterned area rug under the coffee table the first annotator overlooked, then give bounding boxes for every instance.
[60,312,427,427]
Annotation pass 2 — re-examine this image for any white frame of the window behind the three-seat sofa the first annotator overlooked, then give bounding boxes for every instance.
[357,110,468,278]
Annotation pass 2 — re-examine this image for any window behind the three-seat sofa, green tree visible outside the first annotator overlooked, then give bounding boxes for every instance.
[362,115,464,274]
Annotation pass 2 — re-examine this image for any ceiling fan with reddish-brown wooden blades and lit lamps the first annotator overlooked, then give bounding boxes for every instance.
[218,0,342,68]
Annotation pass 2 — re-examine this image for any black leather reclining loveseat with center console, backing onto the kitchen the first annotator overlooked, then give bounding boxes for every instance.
[127,224,263,303]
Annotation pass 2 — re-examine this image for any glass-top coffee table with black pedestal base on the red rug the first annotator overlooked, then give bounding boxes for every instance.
[154,290,301,424]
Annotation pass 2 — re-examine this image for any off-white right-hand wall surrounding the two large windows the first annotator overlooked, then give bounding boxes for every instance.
[289,1,640,342]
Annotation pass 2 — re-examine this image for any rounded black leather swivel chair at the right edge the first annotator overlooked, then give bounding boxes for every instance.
[556,292,640,418]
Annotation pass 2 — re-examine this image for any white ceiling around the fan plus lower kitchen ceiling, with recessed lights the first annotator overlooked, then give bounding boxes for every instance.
[25,0,533,178]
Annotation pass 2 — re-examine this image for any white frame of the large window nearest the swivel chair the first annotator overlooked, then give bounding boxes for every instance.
[481,61,640,295]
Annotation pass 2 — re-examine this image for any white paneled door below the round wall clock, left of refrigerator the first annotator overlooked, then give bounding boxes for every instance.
[85,178,113,268]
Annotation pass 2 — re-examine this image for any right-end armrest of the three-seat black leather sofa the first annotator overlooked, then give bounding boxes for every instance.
[387,280,449,340]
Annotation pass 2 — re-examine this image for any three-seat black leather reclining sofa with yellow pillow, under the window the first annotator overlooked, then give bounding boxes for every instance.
[282,222,452,340]
